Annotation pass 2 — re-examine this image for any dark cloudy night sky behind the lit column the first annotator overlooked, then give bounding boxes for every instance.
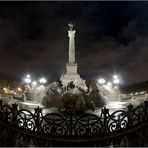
[0,1,148,84]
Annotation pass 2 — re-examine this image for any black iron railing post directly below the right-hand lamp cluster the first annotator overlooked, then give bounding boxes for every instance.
[101,107,109,133]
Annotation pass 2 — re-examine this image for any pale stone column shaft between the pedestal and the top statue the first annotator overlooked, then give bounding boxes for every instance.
[68,30,76,63]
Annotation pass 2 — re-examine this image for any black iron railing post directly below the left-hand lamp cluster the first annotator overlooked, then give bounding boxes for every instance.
[35,106,42,132]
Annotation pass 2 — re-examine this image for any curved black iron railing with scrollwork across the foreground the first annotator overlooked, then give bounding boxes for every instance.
[0,100,148,146]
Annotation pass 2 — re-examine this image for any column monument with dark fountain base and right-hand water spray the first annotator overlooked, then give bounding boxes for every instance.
[35,23,119,110]
